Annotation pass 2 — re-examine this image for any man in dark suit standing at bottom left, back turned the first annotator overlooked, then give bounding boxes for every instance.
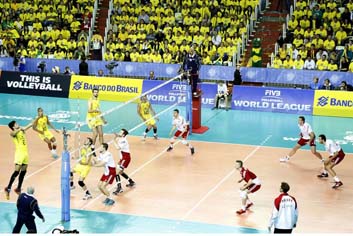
[12,187,45,234]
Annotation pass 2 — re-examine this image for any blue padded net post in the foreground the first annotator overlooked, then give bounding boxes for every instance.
[61,127,70,222]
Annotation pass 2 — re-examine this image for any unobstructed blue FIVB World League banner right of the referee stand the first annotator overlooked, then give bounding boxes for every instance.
[232,86,314,115]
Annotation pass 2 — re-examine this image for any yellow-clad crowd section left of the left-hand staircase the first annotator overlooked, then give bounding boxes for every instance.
[0,0,94,59]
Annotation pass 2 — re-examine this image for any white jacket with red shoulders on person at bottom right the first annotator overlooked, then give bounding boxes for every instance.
[269,193,298,229]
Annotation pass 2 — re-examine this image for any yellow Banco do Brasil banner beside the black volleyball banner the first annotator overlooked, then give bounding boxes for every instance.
[69,75,143,102]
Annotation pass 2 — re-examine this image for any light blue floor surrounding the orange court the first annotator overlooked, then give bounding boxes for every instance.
[0,94,353,233]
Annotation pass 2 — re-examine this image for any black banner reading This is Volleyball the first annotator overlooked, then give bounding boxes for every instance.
[0,71,70,98]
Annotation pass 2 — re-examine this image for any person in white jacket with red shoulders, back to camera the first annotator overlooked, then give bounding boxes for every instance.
[268,182,298,234]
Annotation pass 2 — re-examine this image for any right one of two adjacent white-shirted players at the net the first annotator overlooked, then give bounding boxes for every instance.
[113,129,136,195]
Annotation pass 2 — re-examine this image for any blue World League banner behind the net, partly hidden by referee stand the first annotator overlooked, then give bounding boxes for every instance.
[142,80,217,107]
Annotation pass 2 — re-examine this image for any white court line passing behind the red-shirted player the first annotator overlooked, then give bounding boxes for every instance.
[180,135,272,220]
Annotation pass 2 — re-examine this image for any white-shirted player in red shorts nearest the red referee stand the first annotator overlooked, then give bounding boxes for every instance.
[167,109,195,155]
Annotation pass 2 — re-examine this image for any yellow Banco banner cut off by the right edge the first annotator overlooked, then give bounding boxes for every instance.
[314,90,353,117]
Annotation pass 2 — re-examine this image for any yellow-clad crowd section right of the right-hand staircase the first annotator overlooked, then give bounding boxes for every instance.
[271,0,353,72]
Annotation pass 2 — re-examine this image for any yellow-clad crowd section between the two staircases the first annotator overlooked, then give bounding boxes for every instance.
[104,0,259,64]
